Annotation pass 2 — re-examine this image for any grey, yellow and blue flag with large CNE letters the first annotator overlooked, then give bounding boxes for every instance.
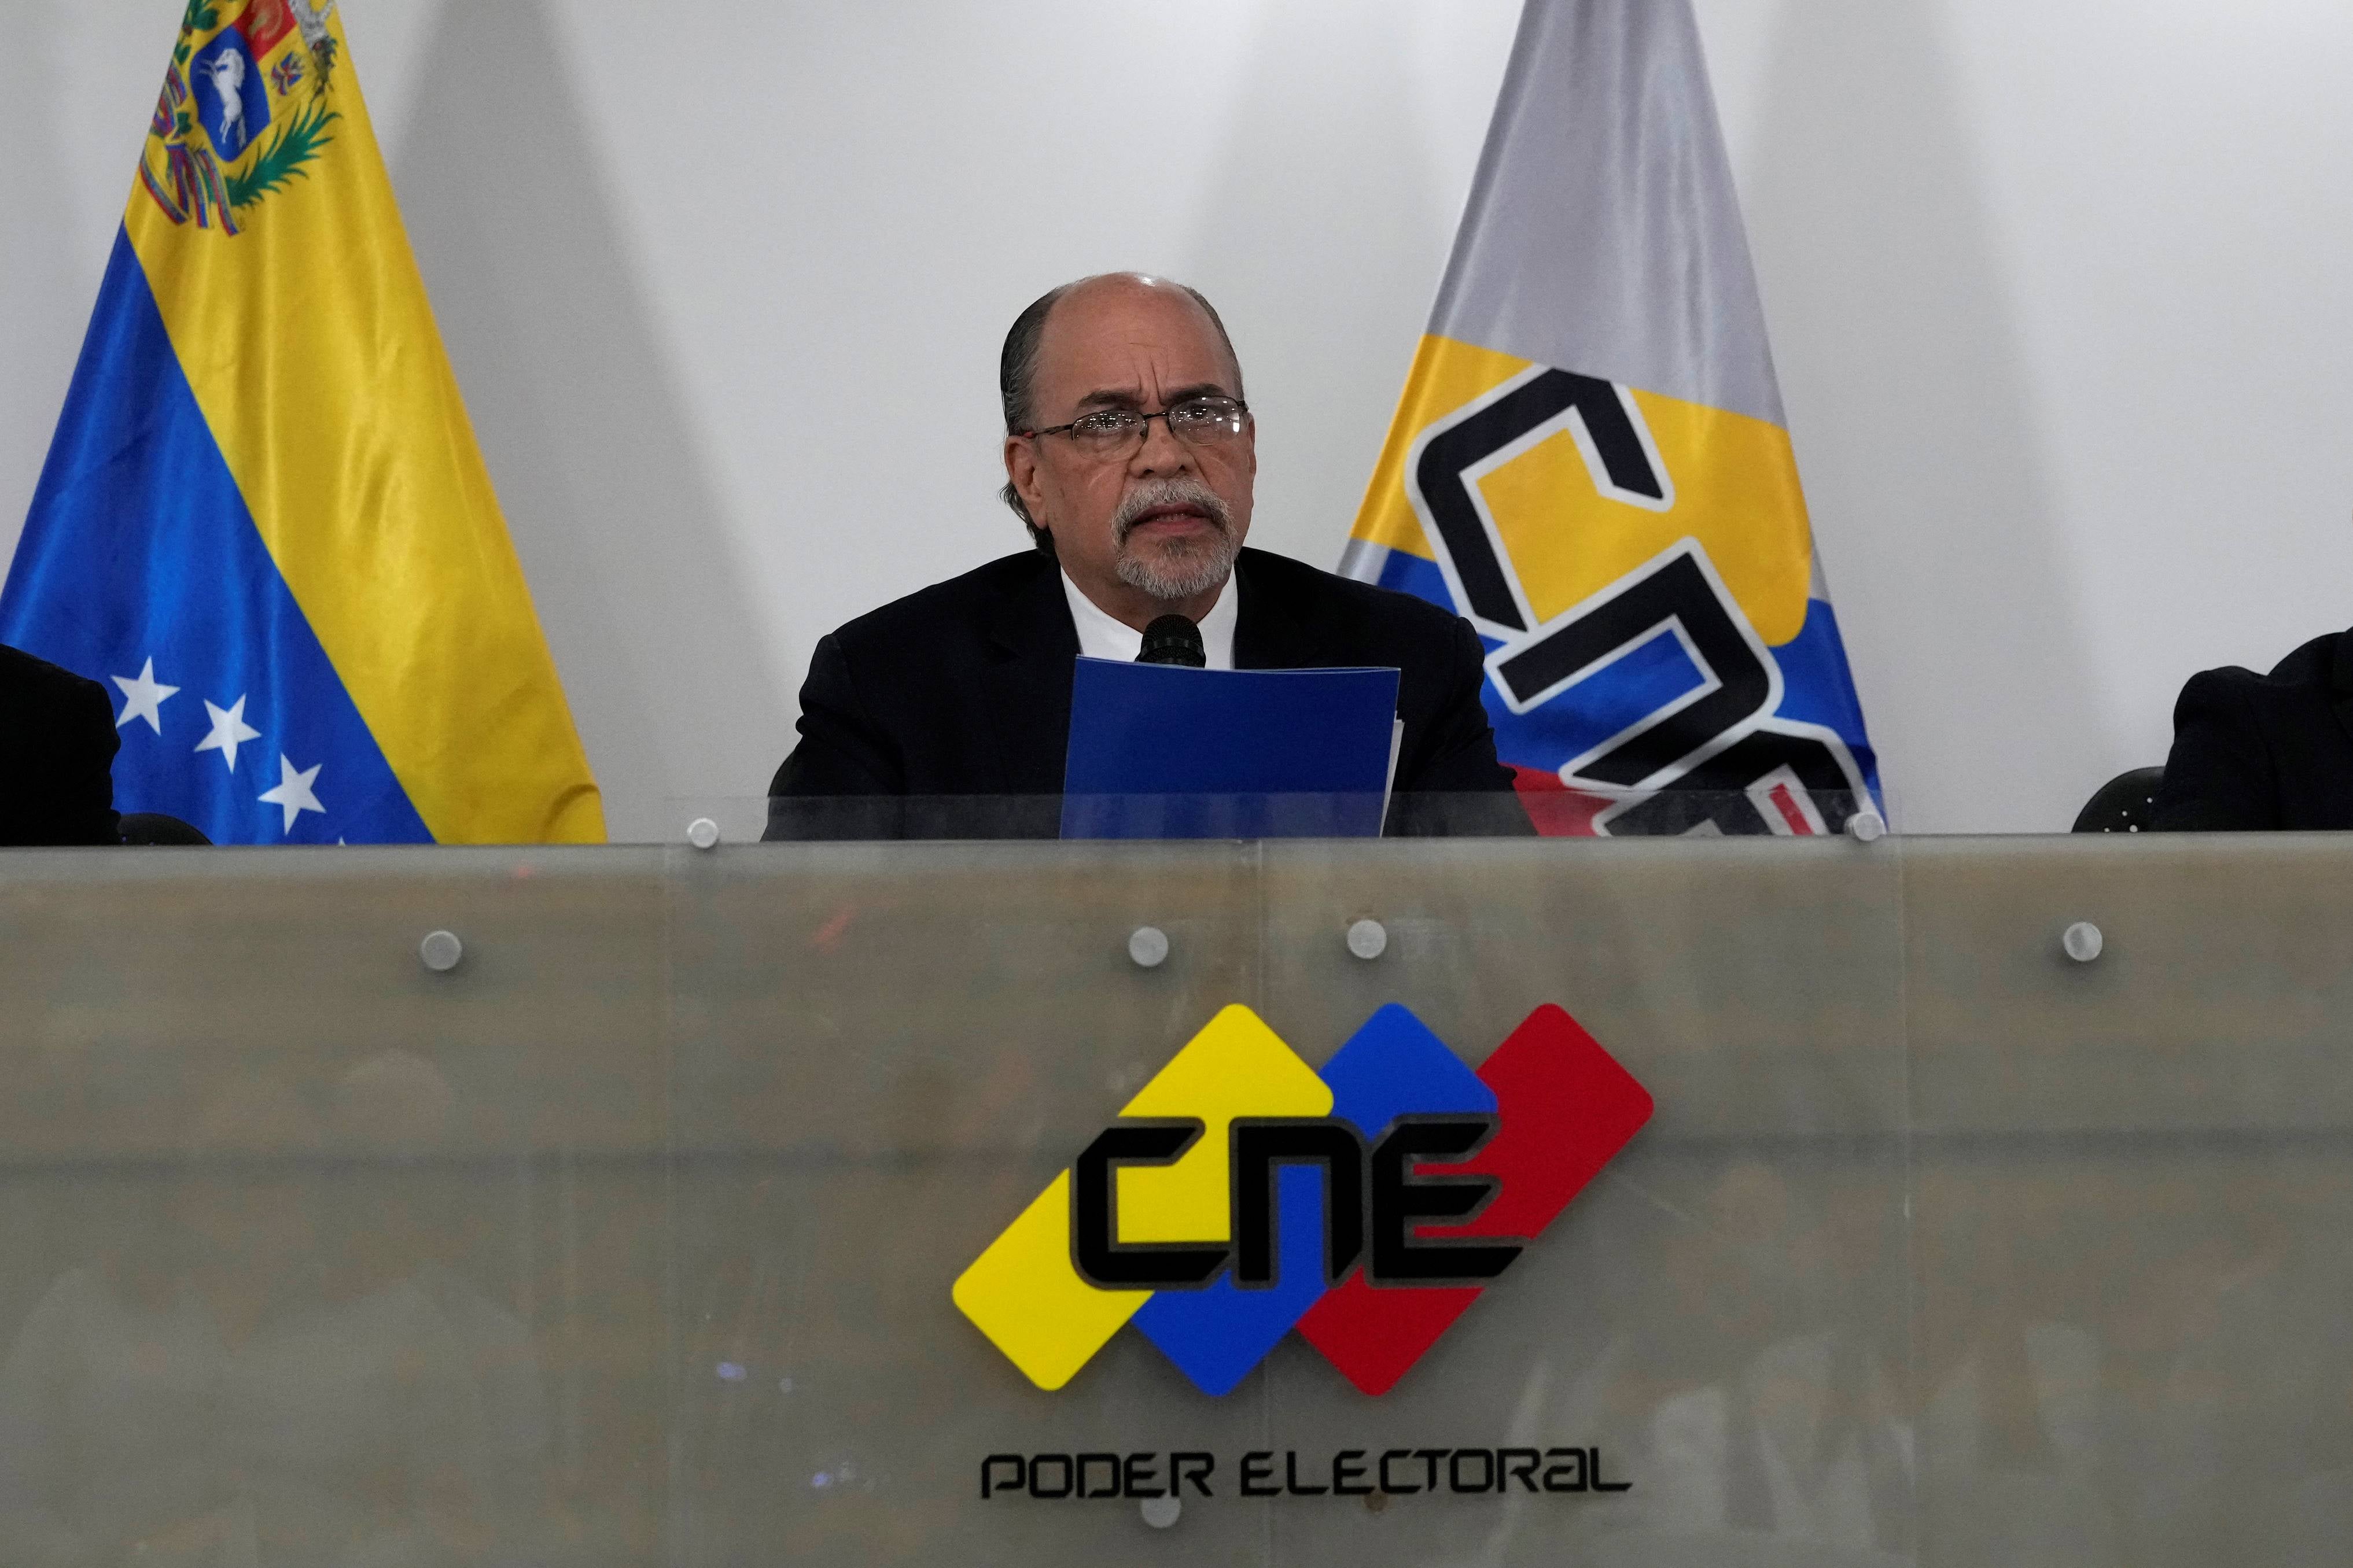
[1341,0,1877,832]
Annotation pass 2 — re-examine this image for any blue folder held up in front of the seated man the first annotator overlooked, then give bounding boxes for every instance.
[1061,658,1398,839]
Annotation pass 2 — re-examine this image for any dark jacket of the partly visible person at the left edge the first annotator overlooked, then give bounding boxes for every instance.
[0,647,122,844]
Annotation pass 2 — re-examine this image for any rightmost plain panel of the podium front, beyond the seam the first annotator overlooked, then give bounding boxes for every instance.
[1903,835,2353,1566]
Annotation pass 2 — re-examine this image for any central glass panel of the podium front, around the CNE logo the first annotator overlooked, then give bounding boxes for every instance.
[671,809,1910,1563]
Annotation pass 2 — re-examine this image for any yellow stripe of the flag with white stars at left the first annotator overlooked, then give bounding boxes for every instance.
[122,0,605,844]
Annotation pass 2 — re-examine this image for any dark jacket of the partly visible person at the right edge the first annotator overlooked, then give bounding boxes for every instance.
[2151,632,2353,830]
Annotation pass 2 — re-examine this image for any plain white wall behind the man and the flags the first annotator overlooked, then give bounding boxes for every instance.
[0,0,2353,837]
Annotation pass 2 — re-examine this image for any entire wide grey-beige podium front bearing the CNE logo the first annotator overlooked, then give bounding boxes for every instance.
[0,818,2353,1568]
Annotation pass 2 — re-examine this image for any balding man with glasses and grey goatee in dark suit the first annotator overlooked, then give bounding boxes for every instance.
[769,272,1527,837]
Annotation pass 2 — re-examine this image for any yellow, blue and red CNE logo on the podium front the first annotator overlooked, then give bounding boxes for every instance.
[953,1004,1652,1394]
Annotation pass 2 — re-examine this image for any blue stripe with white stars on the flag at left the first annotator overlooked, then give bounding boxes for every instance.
[0,230,433,844]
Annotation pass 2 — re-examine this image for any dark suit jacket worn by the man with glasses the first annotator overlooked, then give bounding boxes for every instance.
[767,550,1527,837]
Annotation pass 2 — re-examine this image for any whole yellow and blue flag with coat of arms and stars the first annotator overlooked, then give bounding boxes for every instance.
[0,0,605,844]
